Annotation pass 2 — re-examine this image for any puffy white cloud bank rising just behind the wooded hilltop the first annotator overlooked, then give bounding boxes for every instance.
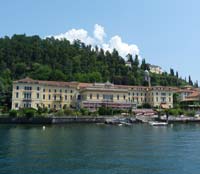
[49,24,140,58]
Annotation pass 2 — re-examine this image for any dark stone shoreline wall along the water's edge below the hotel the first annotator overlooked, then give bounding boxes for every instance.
[0,116,200,124]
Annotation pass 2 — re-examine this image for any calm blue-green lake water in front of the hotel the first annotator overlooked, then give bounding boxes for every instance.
[0,124,200,174]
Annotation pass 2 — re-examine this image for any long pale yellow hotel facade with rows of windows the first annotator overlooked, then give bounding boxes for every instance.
[12,78,177,111]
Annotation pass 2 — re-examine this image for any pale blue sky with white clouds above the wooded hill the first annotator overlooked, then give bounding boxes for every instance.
[0,0,200,81]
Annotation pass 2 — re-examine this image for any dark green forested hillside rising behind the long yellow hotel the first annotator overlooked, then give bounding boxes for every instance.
[0,35,195,109]
